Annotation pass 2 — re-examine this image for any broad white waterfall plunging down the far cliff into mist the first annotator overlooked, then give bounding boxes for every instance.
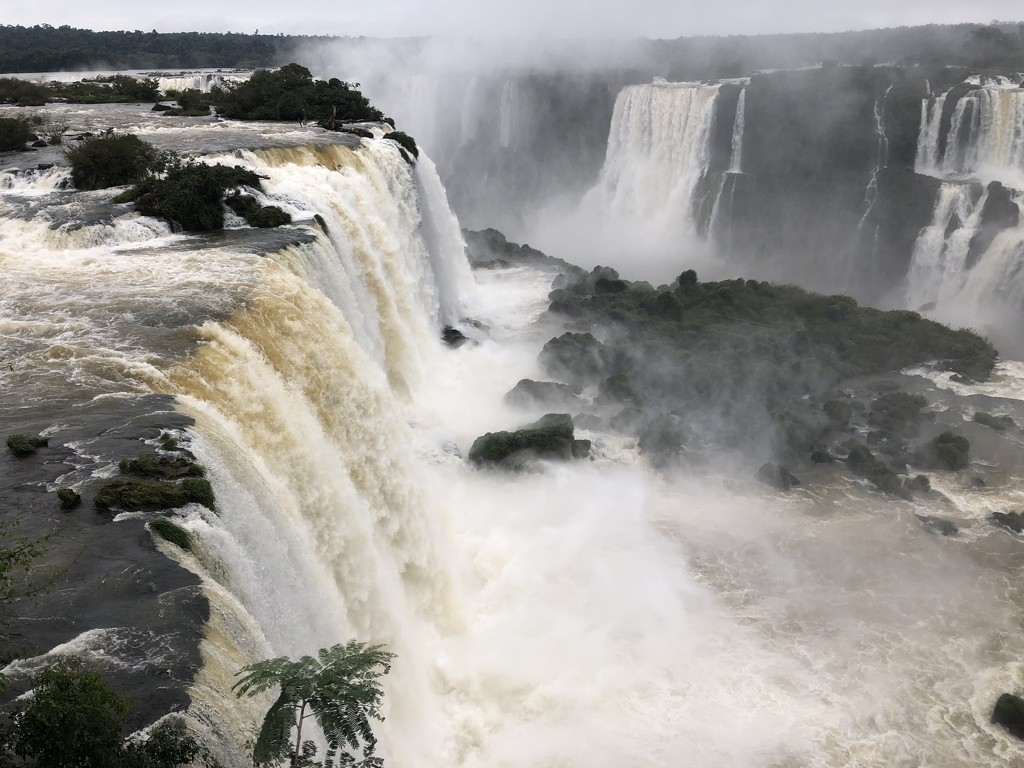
[538,82,719,283]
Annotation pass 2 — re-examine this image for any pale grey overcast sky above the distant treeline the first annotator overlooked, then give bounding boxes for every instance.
[0,0,1024,38]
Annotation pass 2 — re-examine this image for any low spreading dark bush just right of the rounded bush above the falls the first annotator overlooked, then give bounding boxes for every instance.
[114,158,260,231]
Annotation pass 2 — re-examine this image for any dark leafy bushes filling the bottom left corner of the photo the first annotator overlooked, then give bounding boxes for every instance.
[0,657,214,768]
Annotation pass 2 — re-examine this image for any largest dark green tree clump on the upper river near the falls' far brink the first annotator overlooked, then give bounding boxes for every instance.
[213,63,384,127]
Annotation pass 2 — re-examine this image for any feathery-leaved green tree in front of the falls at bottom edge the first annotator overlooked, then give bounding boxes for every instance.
[233,640,394,768]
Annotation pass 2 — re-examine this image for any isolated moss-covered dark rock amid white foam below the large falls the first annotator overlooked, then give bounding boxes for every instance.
[469,414,590,469]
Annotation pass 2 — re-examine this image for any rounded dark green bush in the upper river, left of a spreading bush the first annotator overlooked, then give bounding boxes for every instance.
[65,131,158,189]
